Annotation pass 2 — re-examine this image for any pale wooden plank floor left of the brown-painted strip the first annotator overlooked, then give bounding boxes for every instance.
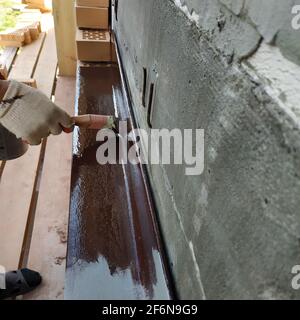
[0,14,75,300]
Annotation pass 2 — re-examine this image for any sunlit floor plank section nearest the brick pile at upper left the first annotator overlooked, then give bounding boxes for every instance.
[8,33,46,79]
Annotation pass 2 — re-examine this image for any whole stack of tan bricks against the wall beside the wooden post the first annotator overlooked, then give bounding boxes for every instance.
[75,0,116,62]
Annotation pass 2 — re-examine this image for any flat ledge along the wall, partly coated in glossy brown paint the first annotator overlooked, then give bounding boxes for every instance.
[65,66,172,299]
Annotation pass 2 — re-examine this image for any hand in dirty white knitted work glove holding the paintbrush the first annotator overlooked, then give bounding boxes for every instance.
[0,81,74,145]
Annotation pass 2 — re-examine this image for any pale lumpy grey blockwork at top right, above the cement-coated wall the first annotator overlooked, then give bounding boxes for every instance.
[174,0,300,64]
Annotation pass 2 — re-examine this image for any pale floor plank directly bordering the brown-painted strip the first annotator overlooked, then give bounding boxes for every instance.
[24,77,75,300]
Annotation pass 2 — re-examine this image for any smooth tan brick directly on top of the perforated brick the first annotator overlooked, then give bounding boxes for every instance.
[75,5,109,29]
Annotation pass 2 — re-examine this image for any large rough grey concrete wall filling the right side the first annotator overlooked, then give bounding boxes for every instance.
[115,0,300,299]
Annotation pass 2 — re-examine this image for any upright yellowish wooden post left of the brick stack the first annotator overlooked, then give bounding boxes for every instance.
[52,0,77,76]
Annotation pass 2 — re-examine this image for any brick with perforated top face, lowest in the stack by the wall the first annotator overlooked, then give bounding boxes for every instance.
[76,29,111,62]
